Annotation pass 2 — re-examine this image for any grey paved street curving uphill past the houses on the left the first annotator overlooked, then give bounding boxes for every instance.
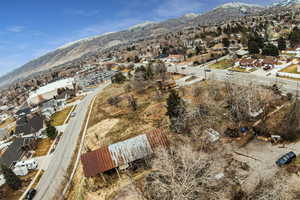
[34,82,110,200]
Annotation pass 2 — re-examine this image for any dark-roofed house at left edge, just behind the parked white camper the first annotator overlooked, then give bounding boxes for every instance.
[0,137,37,168]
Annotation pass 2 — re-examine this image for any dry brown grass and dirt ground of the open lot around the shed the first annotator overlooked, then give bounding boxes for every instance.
[68,79,300,200]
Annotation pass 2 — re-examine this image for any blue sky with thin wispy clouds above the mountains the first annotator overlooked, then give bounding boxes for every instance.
[0,0,276,76]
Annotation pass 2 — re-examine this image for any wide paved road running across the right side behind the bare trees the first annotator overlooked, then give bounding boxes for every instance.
[168,66,300,94]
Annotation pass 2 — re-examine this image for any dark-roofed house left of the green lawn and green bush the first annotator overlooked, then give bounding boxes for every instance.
[15,115,44,136]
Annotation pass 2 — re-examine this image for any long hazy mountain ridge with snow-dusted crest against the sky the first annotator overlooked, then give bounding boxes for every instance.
[0,0,291,85]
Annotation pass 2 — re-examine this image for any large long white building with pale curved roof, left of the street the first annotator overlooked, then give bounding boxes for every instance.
[27,78,75,105]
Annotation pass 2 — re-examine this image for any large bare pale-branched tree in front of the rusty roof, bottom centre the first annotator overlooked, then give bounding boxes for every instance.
[144,146,210,200]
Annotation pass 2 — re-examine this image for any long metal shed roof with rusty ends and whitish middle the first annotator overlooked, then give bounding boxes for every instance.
[81,129,169,177]
